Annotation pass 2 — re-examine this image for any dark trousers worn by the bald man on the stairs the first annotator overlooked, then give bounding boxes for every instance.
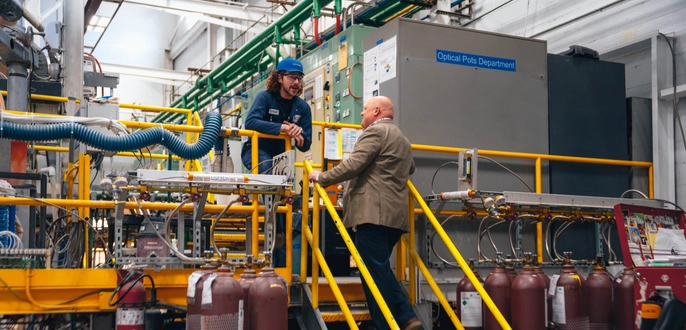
[355,223,416,330]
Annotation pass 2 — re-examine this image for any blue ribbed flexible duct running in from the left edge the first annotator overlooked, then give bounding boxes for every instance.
[0,111,222,159]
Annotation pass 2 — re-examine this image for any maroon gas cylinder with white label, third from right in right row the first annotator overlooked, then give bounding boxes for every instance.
[551,252,588,330]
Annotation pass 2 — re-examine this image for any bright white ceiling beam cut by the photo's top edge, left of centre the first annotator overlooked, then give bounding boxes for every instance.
[126,0,281,22]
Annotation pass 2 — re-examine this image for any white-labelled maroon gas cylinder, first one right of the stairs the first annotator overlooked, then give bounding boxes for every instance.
[455,260,484,330]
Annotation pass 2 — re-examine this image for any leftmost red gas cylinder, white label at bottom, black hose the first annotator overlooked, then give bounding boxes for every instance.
[116,275,145,330]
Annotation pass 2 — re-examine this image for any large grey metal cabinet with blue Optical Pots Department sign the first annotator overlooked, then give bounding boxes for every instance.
[364,19,548,261]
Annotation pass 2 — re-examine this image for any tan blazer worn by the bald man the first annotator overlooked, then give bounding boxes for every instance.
[319,120,415,231]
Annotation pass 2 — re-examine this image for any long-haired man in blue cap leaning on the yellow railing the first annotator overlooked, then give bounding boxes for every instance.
[241,58,312,267]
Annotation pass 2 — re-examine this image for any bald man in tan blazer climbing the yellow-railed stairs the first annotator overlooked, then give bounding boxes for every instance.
[308,96,422,330]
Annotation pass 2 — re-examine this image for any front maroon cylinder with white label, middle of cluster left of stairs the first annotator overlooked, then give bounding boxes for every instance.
[201,265,243,330]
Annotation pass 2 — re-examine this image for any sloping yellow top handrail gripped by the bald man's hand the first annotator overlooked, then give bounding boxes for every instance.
[301,160,400,330]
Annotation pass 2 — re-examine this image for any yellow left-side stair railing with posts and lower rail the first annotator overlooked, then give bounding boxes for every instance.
[300,160,400,330]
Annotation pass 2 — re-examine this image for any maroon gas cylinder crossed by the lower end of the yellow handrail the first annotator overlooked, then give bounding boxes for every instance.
[482,265,512,330]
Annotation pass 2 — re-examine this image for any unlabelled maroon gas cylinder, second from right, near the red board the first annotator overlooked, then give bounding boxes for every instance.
[584,254,612,330]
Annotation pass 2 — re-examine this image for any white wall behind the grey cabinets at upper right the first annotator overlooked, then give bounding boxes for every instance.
[446,0,686,206]
